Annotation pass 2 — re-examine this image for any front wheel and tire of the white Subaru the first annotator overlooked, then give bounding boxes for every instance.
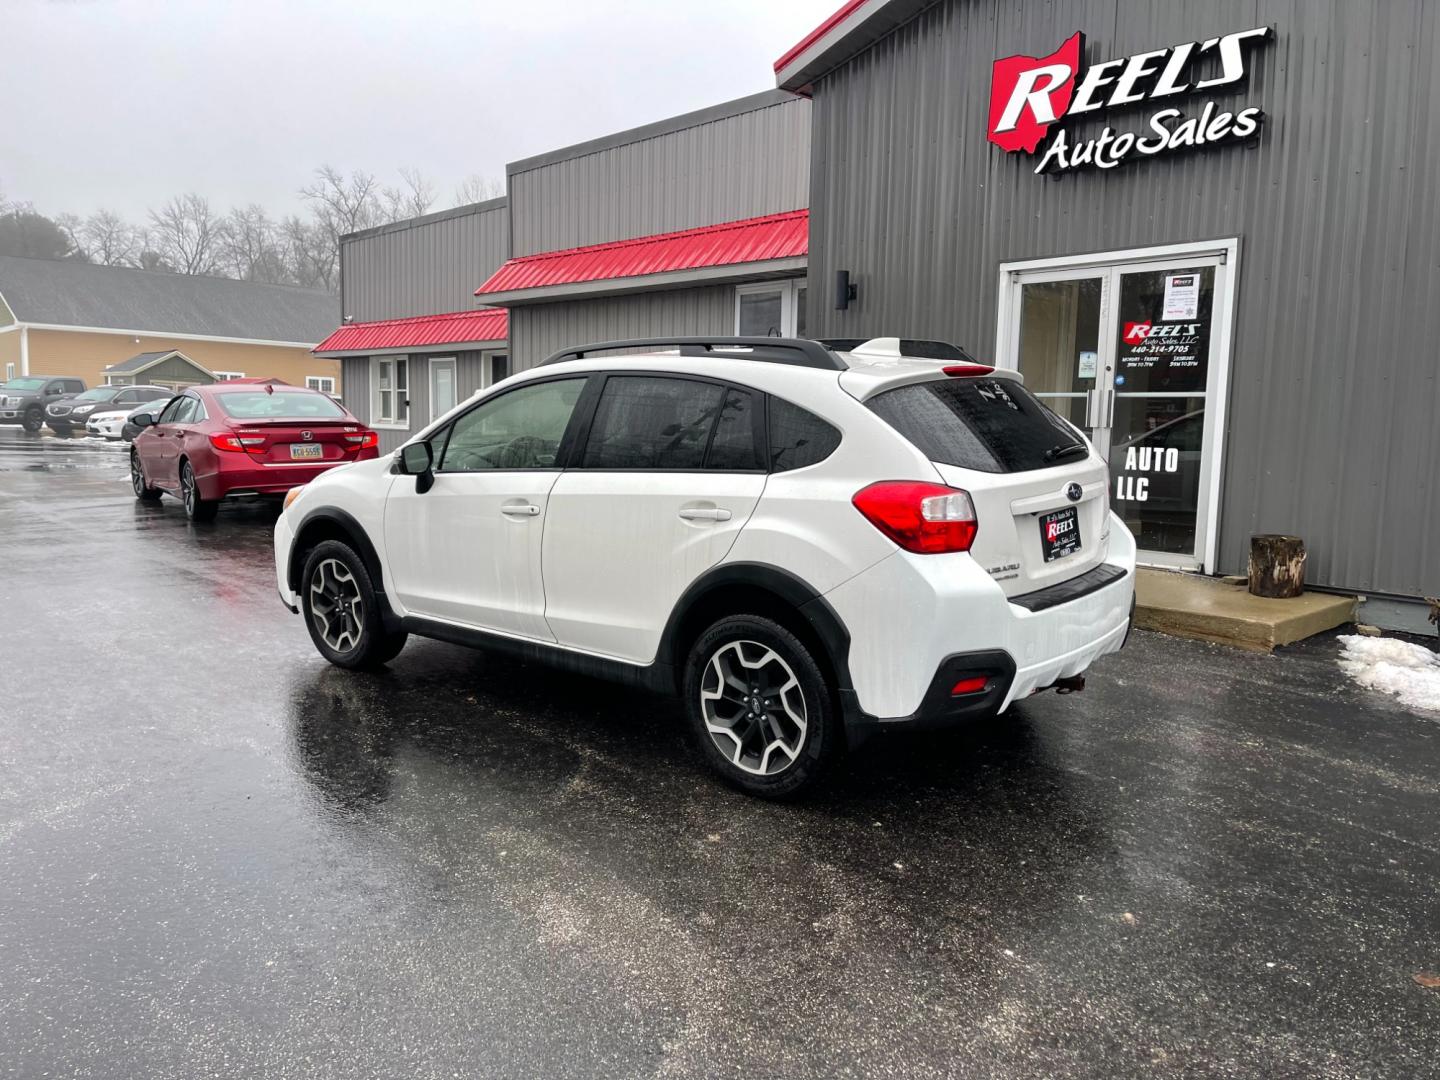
[300,540,409,670]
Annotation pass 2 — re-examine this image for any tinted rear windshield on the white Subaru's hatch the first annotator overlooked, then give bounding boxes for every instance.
[868,379,1083,472]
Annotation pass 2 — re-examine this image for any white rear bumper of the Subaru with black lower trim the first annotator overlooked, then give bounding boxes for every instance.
[825,509,1135,730]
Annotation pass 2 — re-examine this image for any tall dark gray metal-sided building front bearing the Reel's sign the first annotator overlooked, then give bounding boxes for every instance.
[778,0,1440,596]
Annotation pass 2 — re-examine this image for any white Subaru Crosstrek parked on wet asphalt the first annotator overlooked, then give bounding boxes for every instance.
[275,338,1135,795]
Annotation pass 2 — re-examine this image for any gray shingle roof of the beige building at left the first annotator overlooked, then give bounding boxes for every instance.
[0,255,340,346]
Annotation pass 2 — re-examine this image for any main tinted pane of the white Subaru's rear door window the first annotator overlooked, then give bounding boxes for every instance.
[580,376,723,469]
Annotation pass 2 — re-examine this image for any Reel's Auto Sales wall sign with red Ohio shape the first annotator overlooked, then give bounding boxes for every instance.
[989,26,1270,173]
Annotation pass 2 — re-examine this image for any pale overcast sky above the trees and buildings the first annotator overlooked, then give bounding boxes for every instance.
[0,0,838,220]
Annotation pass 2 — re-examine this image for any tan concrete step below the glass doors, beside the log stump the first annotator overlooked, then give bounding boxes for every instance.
[1135,569,1355,652]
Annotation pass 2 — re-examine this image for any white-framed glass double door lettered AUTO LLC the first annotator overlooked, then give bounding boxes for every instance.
[999,255,1228,569]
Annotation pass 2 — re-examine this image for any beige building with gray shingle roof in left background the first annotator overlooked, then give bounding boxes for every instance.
[0,256,341,395]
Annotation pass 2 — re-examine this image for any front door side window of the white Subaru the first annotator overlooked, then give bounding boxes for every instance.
[433,379,585,472]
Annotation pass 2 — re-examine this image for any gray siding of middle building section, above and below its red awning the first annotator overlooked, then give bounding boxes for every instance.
[480,91,809,370]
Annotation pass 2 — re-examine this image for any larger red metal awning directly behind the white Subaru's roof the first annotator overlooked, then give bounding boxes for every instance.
[475,210,809,297]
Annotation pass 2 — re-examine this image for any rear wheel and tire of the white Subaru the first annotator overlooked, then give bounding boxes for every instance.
[683,615,844,798]
